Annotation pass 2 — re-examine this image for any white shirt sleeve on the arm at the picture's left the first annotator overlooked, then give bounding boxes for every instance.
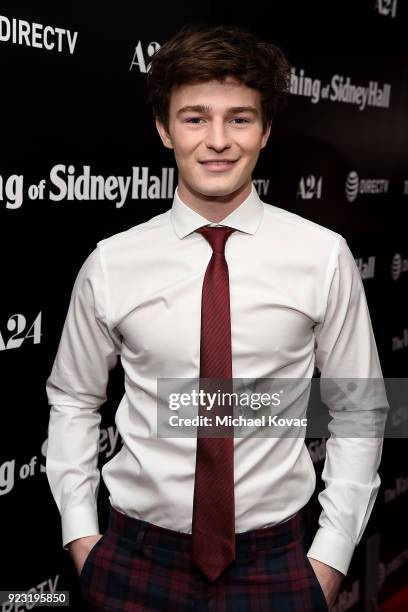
[46,245,121,549]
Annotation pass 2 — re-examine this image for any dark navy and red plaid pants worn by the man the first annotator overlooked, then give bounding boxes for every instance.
[79,507,328,612]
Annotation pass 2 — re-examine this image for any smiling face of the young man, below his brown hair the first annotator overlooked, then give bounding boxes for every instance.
[156,78,271,200]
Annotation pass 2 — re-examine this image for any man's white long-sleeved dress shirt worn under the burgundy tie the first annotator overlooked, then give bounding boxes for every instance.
[46,185,388,574]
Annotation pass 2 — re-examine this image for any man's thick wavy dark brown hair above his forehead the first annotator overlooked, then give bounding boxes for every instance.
[146,23,291,131]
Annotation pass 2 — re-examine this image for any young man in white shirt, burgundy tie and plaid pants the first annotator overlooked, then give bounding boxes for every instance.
[47,25,384,612]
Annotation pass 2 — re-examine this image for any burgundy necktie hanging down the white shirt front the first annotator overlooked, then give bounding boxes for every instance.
[191,226,235,580]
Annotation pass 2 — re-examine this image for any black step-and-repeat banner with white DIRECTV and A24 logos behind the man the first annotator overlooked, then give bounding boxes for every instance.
[0,0,408,612]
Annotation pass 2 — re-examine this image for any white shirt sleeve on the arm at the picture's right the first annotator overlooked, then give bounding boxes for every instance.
[307,236,389,575]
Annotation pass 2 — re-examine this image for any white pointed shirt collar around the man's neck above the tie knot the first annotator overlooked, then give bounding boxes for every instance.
[170,183,264,238]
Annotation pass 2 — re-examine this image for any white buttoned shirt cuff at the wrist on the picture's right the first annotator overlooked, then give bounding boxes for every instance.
[307,527,355,576]
